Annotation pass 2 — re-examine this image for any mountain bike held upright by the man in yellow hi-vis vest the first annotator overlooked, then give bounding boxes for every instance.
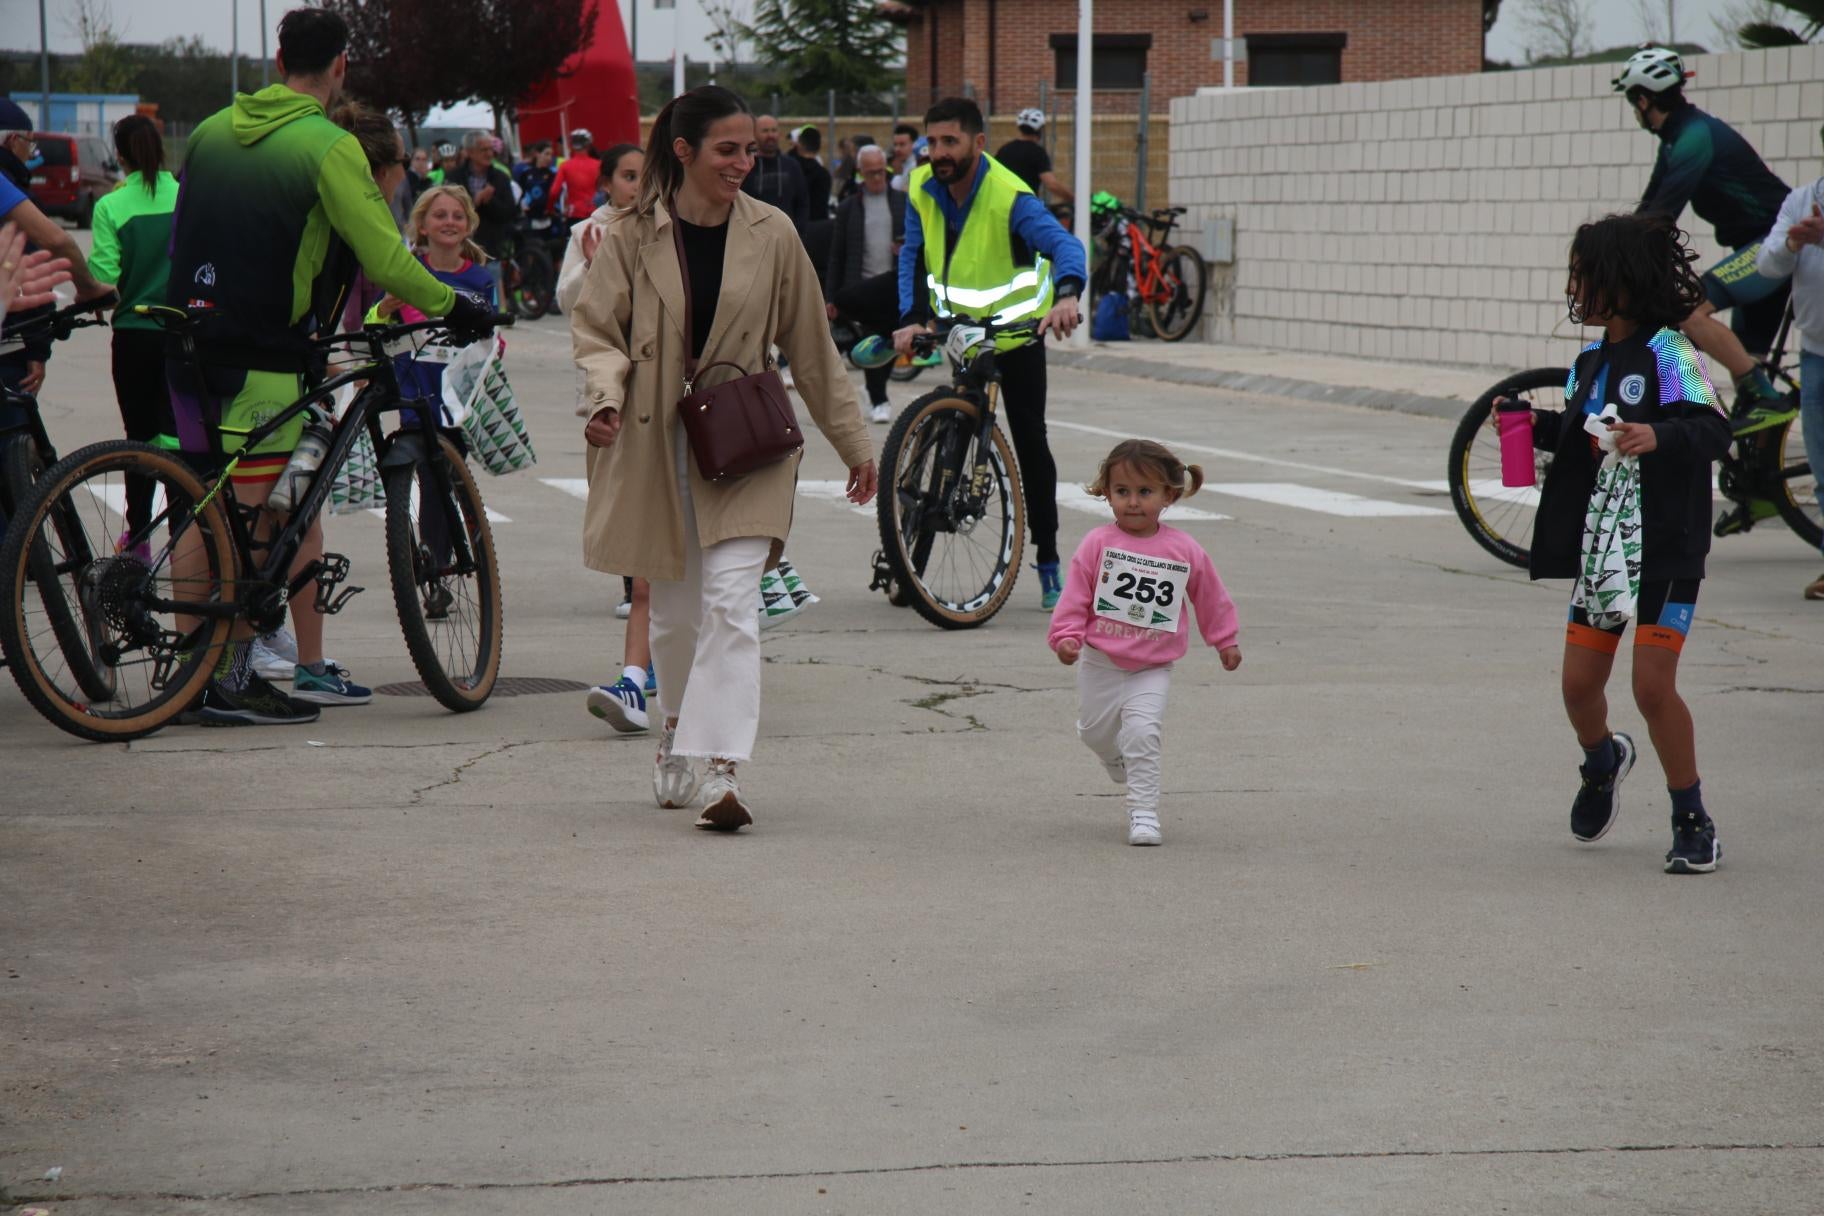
[868,321,1038,629]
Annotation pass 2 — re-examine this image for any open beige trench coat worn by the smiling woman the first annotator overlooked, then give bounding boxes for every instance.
[571,195,874,582]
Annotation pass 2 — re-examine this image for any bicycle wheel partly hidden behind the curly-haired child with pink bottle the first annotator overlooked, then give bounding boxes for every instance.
[1450,366,1569,567]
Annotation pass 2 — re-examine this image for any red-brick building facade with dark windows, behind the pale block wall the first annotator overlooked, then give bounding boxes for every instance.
[886,0,1483,113]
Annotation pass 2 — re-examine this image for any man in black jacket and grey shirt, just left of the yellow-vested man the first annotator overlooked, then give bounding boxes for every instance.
[823,144,907,423]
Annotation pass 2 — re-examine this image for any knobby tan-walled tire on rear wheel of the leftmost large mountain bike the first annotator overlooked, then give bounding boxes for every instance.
[0,439,237,742]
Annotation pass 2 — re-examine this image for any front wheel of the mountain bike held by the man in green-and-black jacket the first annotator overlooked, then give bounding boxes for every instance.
[383,438,503,713]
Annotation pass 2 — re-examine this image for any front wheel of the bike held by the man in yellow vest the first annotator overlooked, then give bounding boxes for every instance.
[877,390,1025,629]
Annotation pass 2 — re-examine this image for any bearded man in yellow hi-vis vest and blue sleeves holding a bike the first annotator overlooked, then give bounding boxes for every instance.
[894,97,1089,609]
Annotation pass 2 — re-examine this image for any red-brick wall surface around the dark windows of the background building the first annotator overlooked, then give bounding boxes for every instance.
[907,0,1483,113]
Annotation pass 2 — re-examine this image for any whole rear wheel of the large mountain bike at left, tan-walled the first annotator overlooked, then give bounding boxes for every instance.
[0,439,235,742]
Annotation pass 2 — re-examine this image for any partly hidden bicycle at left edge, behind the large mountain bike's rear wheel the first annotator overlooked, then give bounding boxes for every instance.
[0,295,119,696]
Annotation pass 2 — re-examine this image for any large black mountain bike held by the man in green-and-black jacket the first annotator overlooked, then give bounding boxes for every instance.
[0,306,513,742]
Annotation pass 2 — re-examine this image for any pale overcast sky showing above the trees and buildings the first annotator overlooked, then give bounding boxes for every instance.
[0,0,1751,62]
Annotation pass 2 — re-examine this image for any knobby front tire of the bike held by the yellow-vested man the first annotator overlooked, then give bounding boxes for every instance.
[876,388,1025,629]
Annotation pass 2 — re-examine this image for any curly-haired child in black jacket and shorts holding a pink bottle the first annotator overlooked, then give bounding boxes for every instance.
[1529,215,1731,873]
